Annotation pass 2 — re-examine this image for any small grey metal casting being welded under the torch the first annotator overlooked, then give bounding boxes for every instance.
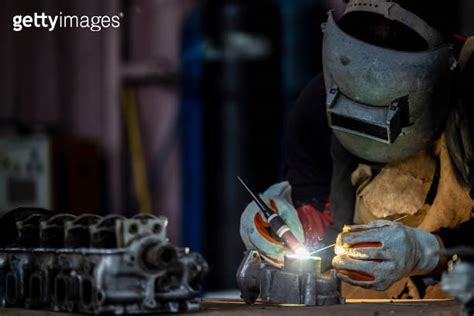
[237,250,344,305]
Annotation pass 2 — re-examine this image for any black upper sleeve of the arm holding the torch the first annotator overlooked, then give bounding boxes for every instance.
[284,74,332,210]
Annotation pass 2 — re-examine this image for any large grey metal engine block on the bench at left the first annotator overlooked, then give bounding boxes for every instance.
[0,210,208,314]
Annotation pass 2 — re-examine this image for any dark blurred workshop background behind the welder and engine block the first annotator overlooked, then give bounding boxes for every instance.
[0,0,468,289]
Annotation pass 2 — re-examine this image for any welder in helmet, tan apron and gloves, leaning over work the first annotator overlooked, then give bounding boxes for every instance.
[240,0,474,298]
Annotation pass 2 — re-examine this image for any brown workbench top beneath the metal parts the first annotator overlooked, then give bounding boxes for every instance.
[0,299,465,316]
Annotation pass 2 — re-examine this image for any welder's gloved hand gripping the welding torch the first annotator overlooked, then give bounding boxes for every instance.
[240,182,304,267]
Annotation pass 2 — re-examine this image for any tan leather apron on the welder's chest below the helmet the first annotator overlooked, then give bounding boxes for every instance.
[351,136,474,231]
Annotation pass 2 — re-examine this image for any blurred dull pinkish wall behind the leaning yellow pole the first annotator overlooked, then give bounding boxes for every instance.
[0,0,194,241]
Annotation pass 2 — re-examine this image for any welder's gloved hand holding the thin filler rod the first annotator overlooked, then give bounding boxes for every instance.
[332,220,440,291]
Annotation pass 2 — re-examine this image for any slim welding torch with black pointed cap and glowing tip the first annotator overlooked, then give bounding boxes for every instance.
[237,177,307,255]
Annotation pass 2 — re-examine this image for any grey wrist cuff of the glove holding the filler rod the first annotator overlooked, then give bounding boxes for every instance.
[410,228,440,275]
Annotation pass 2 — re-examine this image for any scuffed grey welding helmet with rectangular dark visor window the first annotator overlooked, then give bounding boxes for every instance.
[323,0,455,163]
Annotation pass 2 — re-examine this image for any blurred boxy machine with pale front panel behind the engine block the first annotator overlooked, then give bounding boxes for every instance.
[0,134,106,216]
